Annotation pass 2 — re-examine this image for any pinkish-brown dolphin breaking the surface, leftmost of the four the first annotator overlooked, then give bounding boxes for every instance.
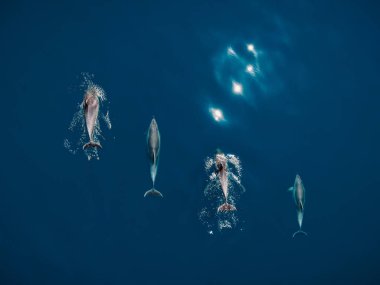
[82,88,102,149]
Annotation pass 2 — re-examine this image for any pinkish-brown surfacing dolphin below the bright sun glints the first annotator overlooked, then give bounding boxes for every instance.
[215,150,236,212]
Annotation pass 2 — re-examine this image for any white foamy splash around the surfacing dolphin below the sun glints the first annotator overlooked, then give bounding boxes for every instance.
[199,154,245,233]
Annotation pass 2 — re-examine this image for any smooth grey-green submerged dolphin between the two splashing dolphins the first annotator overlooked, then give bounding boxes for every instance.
[144,118,163,197]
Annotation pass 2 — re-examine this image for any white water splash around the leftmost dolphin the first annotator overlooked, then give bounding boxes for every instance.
[64,73,112,160]
